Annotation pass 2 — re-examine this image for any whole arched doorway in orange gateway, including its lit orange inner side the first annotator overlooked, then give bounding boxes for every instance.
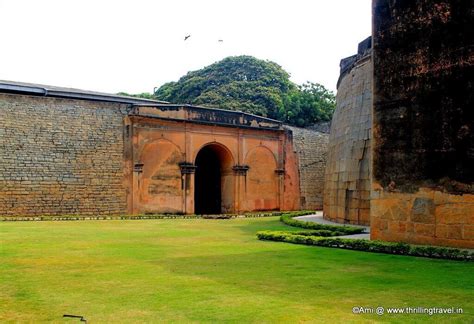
[194,144,234,214]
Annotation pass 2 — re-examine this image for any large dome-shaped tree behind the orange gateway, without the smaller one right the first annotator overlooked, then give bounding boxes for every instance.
[155,56,294,118]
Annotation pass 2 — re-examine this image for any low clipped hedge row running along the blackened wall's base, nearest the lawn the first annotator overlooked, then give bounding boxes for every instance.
[257,231,474,261]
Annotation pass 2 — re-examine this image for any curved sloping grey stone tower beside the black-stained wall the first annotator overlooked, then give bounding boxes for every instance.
[323,37,373,225]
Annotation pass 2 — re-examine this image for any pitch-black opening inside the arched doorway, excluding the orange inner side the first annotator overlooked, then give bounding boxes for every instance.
[194,145,222,214]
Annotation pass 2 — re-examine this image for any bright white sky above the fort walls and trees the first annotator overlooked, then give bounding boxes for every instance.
[0,0,371,93]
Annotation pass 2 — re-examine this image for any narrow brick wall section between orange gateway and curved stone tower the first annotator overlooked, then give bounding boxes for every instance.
[287,126,329,209]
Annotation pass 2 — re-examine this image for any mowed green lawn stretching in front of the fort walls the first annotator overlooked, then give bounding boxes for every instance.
[0,217,474,323]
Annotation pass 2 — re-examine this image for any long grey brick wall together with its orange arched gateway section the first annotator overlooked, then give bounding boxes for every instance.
[0,85,300,216]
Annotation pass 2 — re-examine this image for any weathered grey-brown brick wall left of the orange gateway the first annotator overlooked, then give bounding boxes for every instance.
[0,94,126,216]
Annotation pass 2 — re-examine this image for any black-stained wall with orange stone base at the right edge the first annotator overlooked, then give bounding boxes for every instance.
[371,0,474,248]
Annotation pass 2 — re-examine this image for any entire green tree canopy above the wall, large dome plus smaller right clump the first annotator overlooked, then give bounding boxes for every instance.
[122,56,335,127]
